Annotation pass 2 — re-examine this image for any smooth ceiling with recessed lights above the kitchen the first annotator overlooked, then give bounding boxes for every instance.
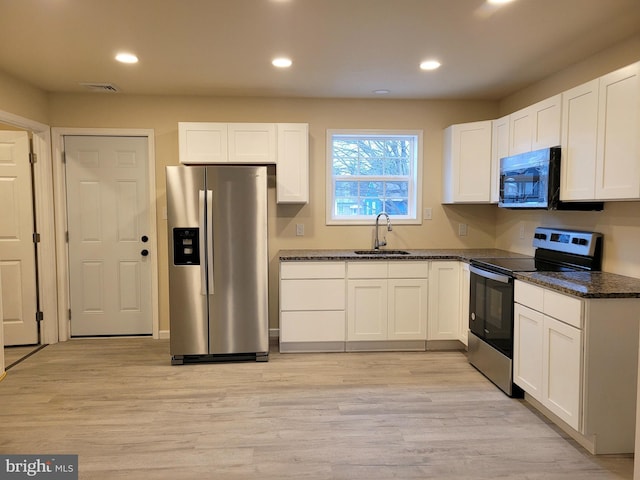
[0,0,640,99]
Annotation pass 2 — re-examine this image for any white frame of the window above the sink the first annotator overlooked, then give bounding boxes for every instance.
[325,129,424,225]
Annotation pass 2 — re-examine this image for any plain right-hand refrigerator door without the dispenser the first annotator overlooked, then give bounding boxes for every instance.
[207,166,269,355]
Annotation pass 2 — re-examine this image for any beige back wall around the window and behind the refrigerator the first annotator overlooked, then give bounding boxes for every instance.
[50,93,497,330]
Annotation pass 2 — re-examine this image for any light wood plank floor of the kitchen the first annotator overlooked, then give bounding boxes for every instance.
[0,339,633,480]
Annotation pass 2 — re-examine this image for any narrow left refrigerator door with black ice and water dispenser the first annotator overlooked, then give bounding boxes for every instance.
[166,166,209,357]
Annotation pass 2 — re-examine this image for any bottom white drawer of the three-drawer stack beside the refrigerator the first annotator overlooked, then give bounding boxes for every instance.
[280,310,346,342]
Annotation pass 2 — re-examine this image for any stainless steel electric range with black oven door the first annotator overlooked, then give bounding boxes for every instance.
[468,227,603,397]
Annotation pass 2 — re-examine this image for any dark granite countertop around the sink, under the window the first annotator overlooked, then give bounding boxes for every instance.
[278,248,529,262]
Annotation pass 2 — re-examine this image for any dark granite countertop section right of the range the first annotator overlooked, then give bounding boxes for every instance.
[515,272,640,298]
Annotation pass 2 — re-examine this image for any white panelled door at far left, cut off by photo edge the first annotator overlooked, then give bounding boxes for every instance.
[0,131,38,345]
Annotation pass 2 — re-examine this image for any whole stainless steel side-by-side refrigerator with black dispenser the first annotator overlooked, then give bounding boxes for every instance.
[166,165,269,365]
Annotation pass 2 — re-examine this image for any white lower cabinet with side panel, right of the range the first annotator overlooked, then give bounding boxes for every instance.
[513,280,640,454]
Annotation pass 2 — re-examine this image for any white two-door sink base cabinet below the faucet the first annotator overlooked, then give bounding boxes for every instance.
[347,261,429,350]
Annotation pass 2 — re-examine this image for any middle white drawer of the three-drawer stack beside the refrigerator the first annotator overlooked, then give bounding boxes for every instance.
[280,279,346,310]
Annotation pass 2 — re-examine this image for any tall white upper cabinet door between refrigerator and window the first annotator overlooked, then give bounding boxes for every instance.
[276,123,309,203]
